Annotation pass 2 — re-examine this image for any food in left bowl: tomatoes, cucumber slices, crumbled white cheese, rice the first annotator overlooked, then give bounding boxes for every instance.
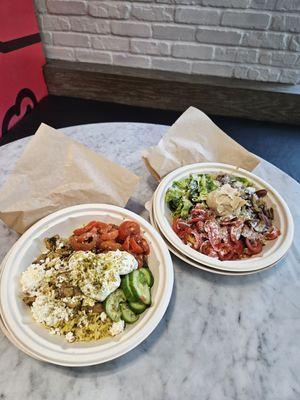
[20,220,154,342]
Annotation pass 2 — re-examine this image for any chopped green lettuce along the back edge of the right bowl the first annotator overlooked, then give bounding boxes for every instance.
[166,174,252,219]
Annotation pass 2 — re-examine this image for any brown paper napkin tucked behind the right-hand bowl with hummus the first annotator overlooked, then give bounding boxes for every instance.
[143,107,259,180]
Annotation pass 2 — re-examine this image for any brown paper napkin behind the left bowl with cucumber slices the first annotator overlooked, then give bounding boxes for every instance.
[0,124,139,233]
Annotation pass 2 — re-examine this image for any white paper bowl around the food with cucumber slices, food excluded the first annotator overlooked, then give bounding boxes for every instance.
[0,204,174,366]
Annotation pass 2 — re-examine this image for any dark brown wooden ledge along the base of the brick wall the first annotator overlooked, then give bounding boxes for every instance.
[44,60,300,124]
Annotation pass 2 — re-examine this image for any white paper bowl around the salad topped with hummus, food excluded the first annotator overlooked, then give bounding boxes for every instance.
[153,163,294,272]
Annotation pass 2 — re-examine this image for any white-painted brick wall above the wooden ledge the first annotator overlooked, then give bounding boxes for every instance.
[35,0,300,84]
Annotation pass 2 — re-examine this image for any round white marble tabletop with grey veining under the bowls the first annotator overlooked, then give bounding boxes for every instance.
[0,123,300,400]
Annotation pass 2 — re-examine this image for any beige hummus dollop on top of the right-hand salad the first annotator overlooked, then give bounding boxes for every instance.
[206,183,246,217]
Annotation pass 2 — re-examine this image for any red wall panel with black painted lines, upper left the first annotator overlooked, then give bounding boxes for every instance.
[0,0,47,138]
